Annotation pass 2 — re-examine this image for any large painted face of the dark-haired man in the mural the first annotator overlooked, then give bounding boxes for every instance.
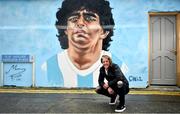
[65,10,107,50]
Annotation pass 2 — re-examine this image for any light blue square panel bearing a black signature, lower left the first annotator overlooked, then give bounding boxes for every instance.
[3,63,33,87]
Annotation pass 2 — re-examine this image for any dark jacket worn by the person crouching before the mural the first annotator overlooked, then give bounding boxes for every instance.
[98,63,129,88]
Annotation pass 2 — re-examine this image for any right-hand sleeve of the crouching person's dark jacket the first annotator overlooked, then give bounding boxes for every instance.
[108,64,124,86]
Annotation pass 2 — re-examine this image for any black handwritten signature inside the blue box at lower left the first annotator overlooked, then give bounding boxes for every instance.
[6,65,26,81]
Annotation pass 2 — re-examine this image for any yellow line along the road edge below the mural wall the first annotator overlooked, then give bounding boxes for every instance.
[0,89,180,96]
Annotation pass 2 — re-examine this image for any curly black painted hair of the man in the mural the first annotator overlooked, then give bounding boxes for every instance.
[55,0,114,51]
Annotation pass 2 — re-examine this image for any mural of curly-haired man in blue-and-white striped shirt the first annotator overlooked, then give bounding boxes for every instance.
[42,0,128,87]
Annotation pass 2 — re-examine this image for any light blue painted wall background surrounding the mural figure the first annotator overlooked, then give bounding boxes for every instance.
[0,0,180,88]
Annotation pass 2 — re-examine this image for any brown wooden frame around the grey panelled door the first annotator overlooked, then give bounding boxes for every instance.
[148,12,180,87]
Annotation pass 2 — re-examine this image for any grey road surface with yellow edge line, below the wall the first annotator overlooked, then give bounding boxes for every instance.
[0,88,180,113]
